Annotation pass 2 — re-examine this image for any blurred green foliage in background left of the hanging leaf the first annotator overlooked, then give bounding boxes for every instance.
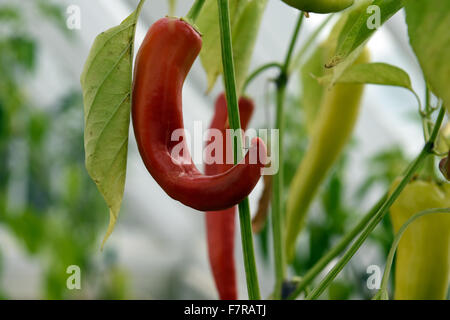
[0,1,128,299]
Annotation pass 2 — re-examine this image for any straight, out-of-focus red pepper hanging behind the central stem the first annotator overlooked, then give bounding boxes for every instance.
[205,93,254,300]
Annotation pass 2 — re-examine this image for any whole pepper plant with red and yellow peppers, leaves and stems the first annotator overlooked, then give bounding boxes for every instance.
[81,0,450,299]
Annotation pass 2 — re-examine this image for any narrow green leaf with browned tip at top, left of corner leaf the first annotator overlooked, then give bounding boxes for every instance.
[327,0,404,82]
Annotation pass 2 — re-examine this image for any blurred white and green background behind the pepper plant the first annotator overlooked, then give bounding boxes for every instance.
[0,0,424,299]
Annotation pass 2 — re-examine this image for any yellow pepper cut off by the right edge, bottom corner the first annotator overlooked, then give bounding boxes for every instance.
[390,179,450,300]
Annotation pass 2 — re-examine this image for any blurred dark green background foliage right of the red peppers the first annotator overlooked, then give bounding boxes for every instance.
[258,84,410,300]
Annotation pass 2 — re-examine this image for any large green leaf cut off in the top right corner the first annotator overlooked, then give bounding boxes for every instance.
[405,0,450,112]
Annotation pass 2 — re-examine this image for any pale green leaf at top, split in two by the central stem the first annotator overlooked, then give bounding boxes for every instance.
[197,0,267,93]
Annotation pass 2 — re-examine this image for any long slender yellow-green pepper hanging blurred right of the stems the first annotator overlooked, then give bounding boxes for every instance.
[285,50,369,261]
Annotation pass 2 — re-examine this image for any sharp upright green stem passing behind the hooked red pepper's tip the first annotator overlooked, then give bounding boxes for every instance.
[217,0,261,300]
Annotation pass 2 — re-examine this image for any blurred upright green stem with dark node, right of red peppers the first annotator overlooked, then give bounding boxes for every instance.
[272,12,304,299]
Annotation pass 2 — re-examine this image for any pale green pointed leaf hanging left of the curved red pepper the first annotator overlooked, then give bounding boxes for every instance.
[81,0,145,247]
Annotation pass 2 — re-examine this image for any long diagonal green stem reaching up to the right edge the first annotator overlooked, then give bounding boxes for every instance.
[306,108,445,300]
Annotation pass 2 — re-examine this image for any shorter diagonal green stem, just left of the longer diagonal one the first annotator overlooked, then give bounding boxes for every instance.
[288,194,388,300]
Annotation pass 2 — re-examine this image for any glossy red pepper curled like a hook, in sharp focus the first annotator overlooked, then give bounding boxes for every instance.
[132,17,267,211]
